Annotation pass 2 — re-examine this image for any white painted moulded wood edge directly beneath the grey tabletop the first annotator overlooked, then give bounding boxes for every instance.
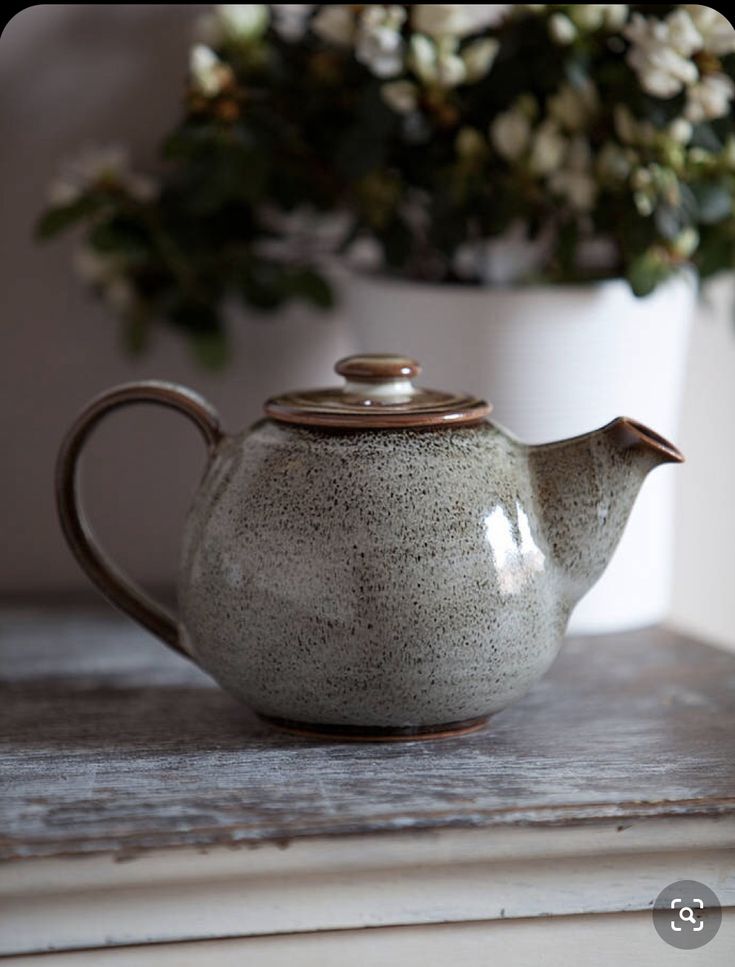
[0,817,735,954]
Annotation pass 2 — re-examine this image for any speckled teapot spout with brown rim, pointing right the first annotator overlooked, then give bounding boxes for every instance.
[529,417,684,605]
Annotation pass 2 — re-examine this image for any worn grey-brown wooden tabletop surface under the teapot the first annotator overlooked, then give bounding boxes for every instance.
[0,606,735,859]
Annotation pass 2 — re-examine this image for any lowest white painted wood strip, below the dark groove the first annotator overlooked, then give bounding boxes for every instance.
[5,909,735,967]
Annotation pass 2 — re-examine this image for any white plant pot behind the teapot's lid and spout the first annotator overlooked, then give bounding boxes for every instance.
[344,275,696,634]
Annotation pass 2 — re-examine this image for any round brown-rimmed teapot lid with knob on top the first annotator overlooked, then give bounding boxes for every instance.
[265,353,492,429]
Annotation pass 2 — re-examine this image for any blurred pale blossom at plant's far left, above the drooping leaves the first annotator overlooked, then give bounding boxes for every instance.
[48,146,158,205]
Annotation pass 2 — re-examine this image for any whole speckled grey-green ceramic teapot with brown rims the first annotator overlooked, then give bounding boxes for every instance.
[57,355,683,739]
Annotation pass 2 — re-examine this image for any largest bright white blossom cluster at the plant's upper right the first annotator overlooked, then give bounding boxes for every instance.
[623,9,702,98]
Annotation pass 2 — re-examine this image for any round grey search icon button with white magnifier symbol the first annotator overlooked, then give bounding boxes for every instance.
[653,880,722,950]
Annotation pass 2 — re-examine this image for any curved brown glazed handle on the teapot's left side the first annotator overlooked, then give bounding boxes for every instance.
[56,380,223,658]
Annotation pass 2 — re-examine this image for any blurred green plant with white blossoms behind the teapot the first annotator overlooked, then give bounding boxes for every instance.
[39,4,735,363]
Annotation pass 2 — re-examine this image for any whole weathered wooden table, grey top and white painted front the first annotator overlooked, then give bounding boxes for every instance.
[0,606,735,967]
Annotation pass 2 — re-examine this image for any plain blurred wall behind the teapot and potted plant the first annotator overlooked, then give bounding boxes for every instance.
[0,4,735,647]
